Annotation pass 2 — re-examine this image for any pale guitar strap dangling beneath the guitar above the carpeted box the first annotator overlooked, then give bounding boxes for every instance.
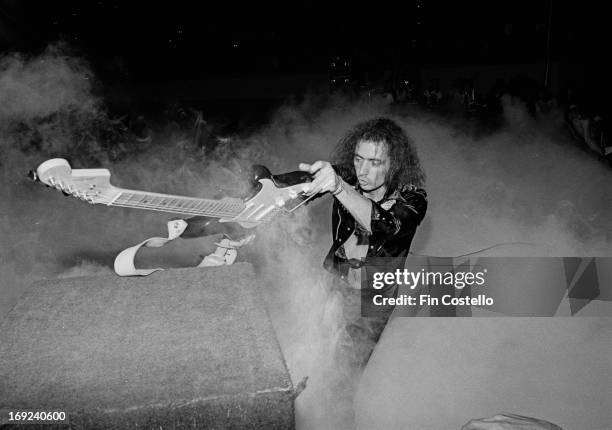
[114,219,255,276]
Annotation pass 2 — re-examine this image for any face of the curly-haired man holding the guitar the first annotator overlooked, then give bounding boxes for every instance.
[353,140,391,192]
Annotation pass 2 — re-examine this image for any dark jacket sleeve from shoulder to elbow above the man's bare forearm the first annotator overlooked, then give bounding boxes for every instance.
[370,188,427,239]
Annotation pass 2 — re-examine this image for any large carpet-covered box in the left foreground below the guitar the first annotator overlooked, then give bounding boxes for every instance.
[0,263,295,429]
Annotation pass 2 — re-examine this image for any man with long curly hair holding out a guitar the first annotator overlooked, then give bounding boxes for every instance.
[300,118,427,370]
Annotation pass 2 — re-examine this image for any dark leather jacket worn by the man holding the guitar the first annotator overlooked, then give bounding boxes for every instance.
[323,166,427,277]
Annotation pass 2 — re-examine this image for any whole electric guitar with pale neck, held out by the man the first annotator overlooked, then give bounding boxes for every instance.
[31,158,312,228]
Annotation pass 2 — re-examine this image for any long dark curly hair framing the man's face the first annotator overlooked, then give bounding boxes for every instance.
[332,117,425,192]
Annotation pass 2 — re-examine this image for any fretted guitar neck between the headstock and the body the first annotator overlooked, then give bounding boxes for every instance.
[107,188,245,218]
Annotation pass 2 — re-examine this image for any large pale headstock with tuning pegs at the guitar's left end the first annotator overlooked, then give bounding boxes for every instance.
[36,158,118,204]
